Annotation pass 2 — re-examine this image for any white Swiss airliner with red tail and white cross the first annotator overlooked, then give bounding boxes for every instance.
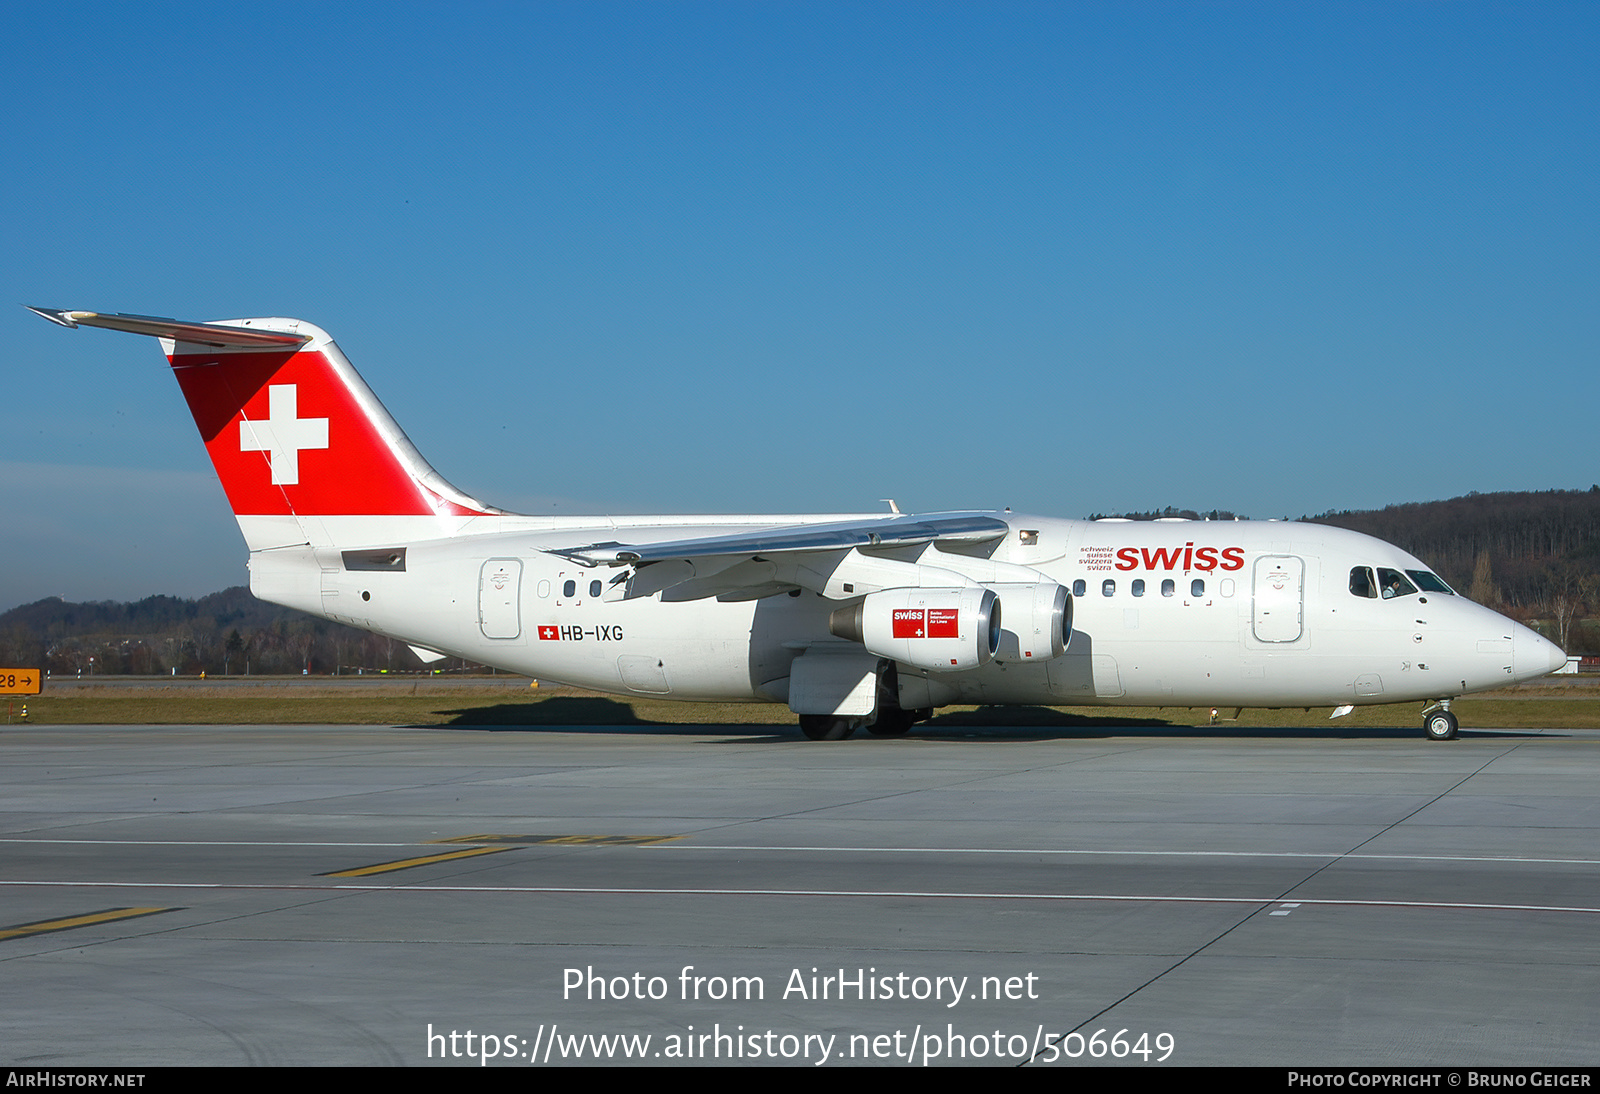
[30,309,1566,741]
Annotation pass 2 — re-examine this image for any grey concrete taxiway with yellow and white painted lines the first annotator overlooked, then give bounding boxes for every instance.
[0,722,1600,1068]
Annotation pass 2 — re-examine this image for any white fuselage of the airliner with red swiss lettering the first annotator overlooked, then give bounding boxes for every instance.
[242,513,1563,709]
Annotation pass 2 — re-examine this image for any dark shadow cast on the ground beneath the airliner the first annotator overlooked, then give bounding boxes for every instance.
[416,696,1541,742]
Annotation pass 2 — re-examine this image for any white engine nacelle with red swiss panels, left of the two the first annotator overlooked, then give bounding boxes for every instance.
[827,585,1000,672]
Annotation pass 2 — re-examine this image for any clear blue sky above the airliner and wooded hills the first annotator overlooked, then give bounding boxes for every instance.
[0,0,1600,608]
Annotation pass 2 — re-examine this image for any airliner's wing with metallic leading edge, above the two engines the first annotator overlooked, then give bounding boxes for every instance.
[550,513,1010,600]
